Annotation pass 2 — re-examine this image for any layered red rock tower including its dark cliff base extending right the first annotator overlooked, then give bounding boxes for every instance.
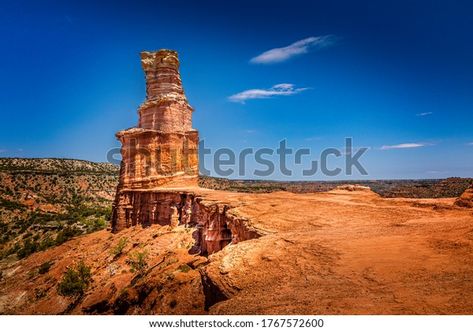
[111,50,260,255]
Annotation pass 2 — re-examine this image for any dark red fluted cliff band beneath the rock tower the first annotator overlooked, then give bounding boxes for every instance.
[111,190,260,255]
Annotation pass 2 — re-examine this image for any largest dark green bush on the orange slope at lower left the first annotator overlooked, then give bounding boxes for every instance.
[57,261,92,297]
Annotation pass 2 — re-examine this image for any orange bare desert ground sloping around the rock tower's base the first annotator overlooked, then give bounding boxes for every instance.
[0,187,473,314]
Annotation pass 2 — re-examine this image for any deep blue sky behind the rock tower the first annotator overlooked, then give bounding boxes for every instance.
[0,0,473,179]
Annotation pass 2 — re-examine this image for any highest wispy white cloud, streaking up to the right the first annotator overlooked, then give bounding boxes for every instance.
[250,35,335,64]
